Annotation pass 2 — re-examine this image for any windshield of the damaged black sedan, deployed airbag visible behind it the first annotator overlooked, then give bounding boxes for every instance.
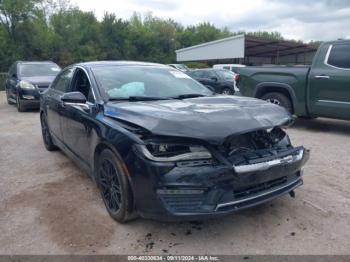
[92,66,212,99]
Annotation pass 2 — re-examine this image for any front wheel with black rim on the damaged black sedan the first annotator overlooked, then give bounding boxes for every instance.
[96,149,133,223]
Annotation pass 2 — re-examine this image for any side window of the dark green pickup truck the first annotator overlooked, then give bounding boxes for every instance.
[327,44,350,69]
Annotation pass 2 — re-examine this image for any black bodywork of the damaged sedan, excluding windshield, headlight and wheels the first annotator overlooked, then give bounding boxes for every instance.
[41,62,309,220]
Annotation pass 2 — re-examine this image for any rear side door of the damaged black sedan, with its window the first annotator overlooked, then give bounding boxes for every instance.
[46,68,73,142]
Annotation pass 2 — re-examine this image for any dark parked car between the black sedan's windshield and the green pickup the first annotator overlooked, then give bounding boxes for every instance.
[188,68,238,95]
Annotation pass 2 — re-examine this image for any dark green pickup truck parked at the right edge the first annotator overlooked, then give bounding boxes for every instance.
[238,40,350,120]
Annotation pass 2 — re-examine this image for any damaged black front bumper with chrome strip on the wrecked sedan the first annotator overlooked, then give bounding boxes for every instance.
[129,147,309,221]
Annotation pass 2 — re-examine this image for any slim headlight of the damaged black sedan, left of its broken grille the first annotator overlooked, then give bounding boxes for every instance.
[135,144,212,162]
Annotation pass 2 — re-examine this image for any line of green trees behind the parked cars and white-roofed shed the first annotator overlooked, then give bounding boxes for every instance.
[0,0,314,72]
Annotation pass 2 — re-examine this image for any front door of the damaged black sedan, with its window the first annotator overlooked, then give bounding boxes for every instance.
[62,68,95,166]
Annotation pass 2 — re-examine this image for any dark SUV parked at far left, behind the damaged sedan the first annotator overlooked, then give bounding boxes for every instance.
[5,61,61,112]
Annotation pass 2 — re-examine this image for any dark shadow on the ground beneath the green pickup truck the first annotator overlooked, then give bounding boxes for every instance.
[291,118,350,135]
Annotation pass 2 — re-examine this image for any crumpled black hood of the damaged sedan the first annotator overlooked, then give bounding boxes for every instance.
[104,96,292,144]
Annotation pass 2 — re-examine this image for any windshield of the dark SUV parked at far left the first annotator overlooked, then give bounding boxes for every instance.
[19,63,61,77]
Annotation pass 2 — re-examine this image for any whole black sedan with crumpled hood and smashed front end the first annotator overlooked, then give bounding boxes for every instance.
[40,61,309,222]
